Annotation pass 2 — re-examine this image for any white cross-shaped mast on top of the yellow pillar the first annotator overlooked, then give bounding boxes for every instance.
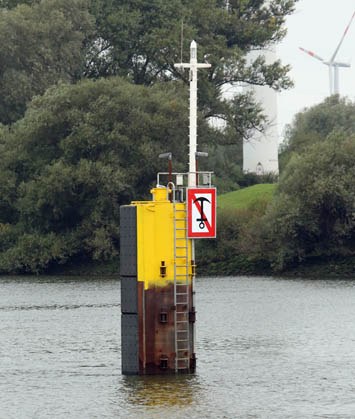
[174,41,211,187]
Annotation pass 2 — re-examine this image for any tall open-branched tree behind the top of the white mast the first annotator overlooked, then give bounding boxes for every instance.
[85,0,296,153]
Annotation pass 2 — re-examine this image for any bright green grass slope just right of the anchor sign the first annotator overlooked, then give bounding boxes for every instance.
[217,183,276,209]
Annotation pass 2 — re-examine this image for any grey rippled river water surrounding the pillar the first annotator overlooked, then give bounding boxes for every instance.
[0,277,355,419]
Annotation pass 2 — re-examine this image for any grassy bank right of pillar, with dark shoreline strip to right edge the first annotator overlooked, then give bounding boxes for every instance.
[196,184,355,279]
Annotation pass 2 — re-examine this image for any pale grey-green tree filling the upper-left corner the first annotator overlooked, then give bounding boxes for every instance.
[0,0,93,124]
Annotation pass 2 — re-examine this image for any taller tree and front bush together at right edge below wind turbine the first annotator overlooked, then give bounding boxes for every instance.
[263,95,355,268]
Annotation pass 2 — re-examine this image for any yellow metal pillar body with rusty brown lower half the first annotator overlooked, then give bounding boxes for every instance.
[123,187,195,373]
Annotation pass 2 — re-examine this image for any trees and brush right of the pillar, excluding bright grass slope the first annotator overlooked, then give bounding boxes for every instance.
[199,96,355,274]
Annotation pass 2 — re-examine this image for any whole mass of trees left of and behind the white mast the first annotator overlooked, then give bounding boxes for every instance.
[0,0,296,272]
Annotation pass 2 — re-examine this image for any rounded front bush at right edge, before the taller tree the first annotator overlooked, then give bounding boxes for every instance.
[260,131,355,269]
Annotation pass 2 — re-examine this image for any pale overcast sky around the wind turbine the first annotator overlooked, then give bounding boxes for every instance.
[277,0,355,141]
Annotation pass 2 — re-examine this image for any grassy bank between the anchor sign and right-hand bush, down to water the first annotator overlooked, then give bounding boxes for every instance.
[196,184,275,275]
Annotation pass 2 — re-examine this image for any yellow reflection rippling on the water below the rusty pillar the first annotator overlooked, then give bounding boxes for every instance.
[121,375,199,407]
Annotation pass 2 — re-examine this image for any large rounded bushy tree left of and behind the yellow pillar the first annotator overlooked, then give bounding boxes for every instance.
[0,78,213,272]
